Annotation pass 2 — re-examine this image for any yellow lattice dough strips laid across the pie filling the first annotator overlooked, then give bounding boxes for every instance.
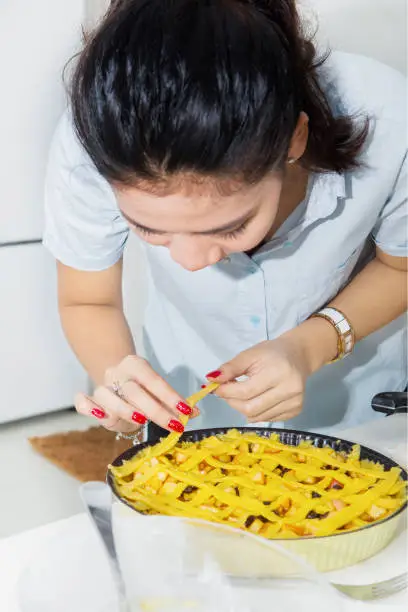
[113,431,404,537]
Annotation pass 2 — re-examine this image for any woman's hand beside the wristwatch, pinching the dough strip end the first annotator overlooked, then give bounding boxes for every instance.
[207,320,337,423]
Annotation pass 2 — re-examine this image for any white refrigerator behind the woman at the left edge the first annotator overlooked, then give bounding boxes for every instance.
[0,0,88,423]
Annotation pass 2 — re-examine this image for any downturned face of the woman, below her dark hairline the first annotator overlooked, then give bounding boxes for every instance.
[115,174,282,271]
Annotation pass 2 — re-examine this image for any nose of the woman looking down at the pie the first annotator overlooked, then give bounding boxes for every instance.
[169,235,224,272]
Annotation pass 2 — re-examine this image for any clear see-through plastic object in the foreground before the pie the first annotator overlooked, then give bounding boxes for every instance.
[113,503,342,612]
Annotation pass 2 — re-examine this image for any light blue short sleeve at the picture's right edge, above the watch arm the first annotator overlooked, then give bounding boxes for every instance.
[373,154,408,257]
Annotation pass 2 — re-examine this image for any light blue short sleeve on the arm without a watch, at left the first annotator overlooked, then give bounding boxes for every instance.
[43,112,129,271]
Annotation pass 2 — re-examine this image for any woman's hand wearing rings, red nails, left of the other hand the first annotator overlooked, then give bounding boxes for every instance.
[75,355,194,433]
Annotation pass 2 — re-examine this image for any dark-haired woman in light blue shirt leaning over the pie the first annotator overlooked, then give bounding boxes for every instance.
[45,0,407,440]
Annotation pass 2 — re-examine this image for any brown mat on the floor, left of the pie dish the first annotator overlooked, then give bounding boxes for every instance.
[29,427,132,482]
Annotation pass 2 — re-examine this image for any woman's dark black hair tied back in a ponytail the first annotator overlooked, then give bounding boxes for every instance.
[71,0,369,183]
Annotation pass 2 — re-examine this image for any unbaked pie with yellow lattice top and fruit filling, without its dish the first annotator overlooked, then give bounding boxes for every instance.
[110,429,406,539]
